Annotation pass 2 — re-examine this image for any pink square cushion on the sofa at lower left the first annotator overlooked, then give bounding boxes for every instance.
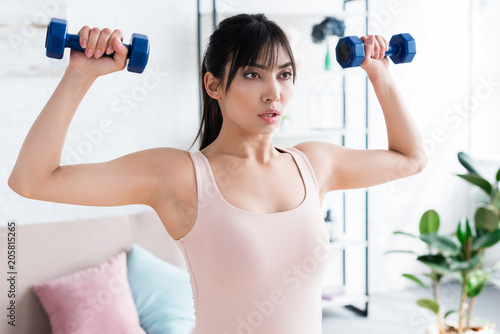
[33,251,146,334]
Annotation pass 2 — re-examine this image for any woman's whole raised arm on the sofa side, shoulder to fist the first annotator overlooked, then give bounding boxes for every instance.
[8,27,184,206]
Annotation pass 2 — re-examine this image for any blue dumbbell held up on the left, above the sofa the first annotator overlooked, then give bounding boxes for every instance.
[45,18,149,73]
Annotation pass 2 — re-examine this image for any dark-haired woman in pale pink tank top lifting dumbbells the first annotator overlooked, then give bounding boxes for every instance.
[9,15,425,334]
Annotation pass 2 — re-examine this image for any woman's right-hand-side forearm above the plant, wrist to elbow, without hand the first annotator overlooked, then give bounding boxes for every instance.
[370,70,425,163]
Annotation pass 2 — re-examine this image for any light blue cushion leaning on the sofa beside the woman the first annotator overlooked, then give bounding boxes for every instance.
[127,243,195,334]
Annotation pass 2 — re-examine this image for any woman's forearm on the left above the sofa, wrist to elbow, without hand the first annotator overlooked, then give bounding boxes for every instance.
[9,68,95,188]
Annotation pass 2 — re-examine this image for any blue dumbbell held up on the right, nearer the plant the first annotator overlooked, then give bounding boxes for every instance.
[335,34,417,68]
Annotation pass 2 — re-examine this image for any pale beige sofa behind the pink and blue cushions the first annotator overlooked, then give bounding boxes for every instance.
[0,210,193,334]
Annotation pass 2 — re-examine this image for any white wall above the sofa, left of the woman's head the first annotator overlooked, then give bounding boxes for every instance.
[0,0,198,225]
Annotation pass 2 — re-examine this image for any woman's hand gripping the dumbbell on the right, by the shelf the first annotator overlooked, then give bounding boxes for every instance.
[360,35,389,77]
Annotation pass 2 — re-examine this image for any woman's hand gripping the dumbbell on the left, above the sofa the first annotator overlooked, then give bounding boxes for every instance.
[69,26,128,79]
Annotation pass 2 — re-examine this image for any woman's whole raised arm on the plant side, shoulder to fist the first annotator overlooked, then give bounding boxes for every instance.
[296,36,426,193]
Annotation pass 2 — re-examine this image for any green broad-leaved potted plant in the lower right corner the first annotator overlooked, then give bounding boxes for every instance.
[388,152,500,334]
